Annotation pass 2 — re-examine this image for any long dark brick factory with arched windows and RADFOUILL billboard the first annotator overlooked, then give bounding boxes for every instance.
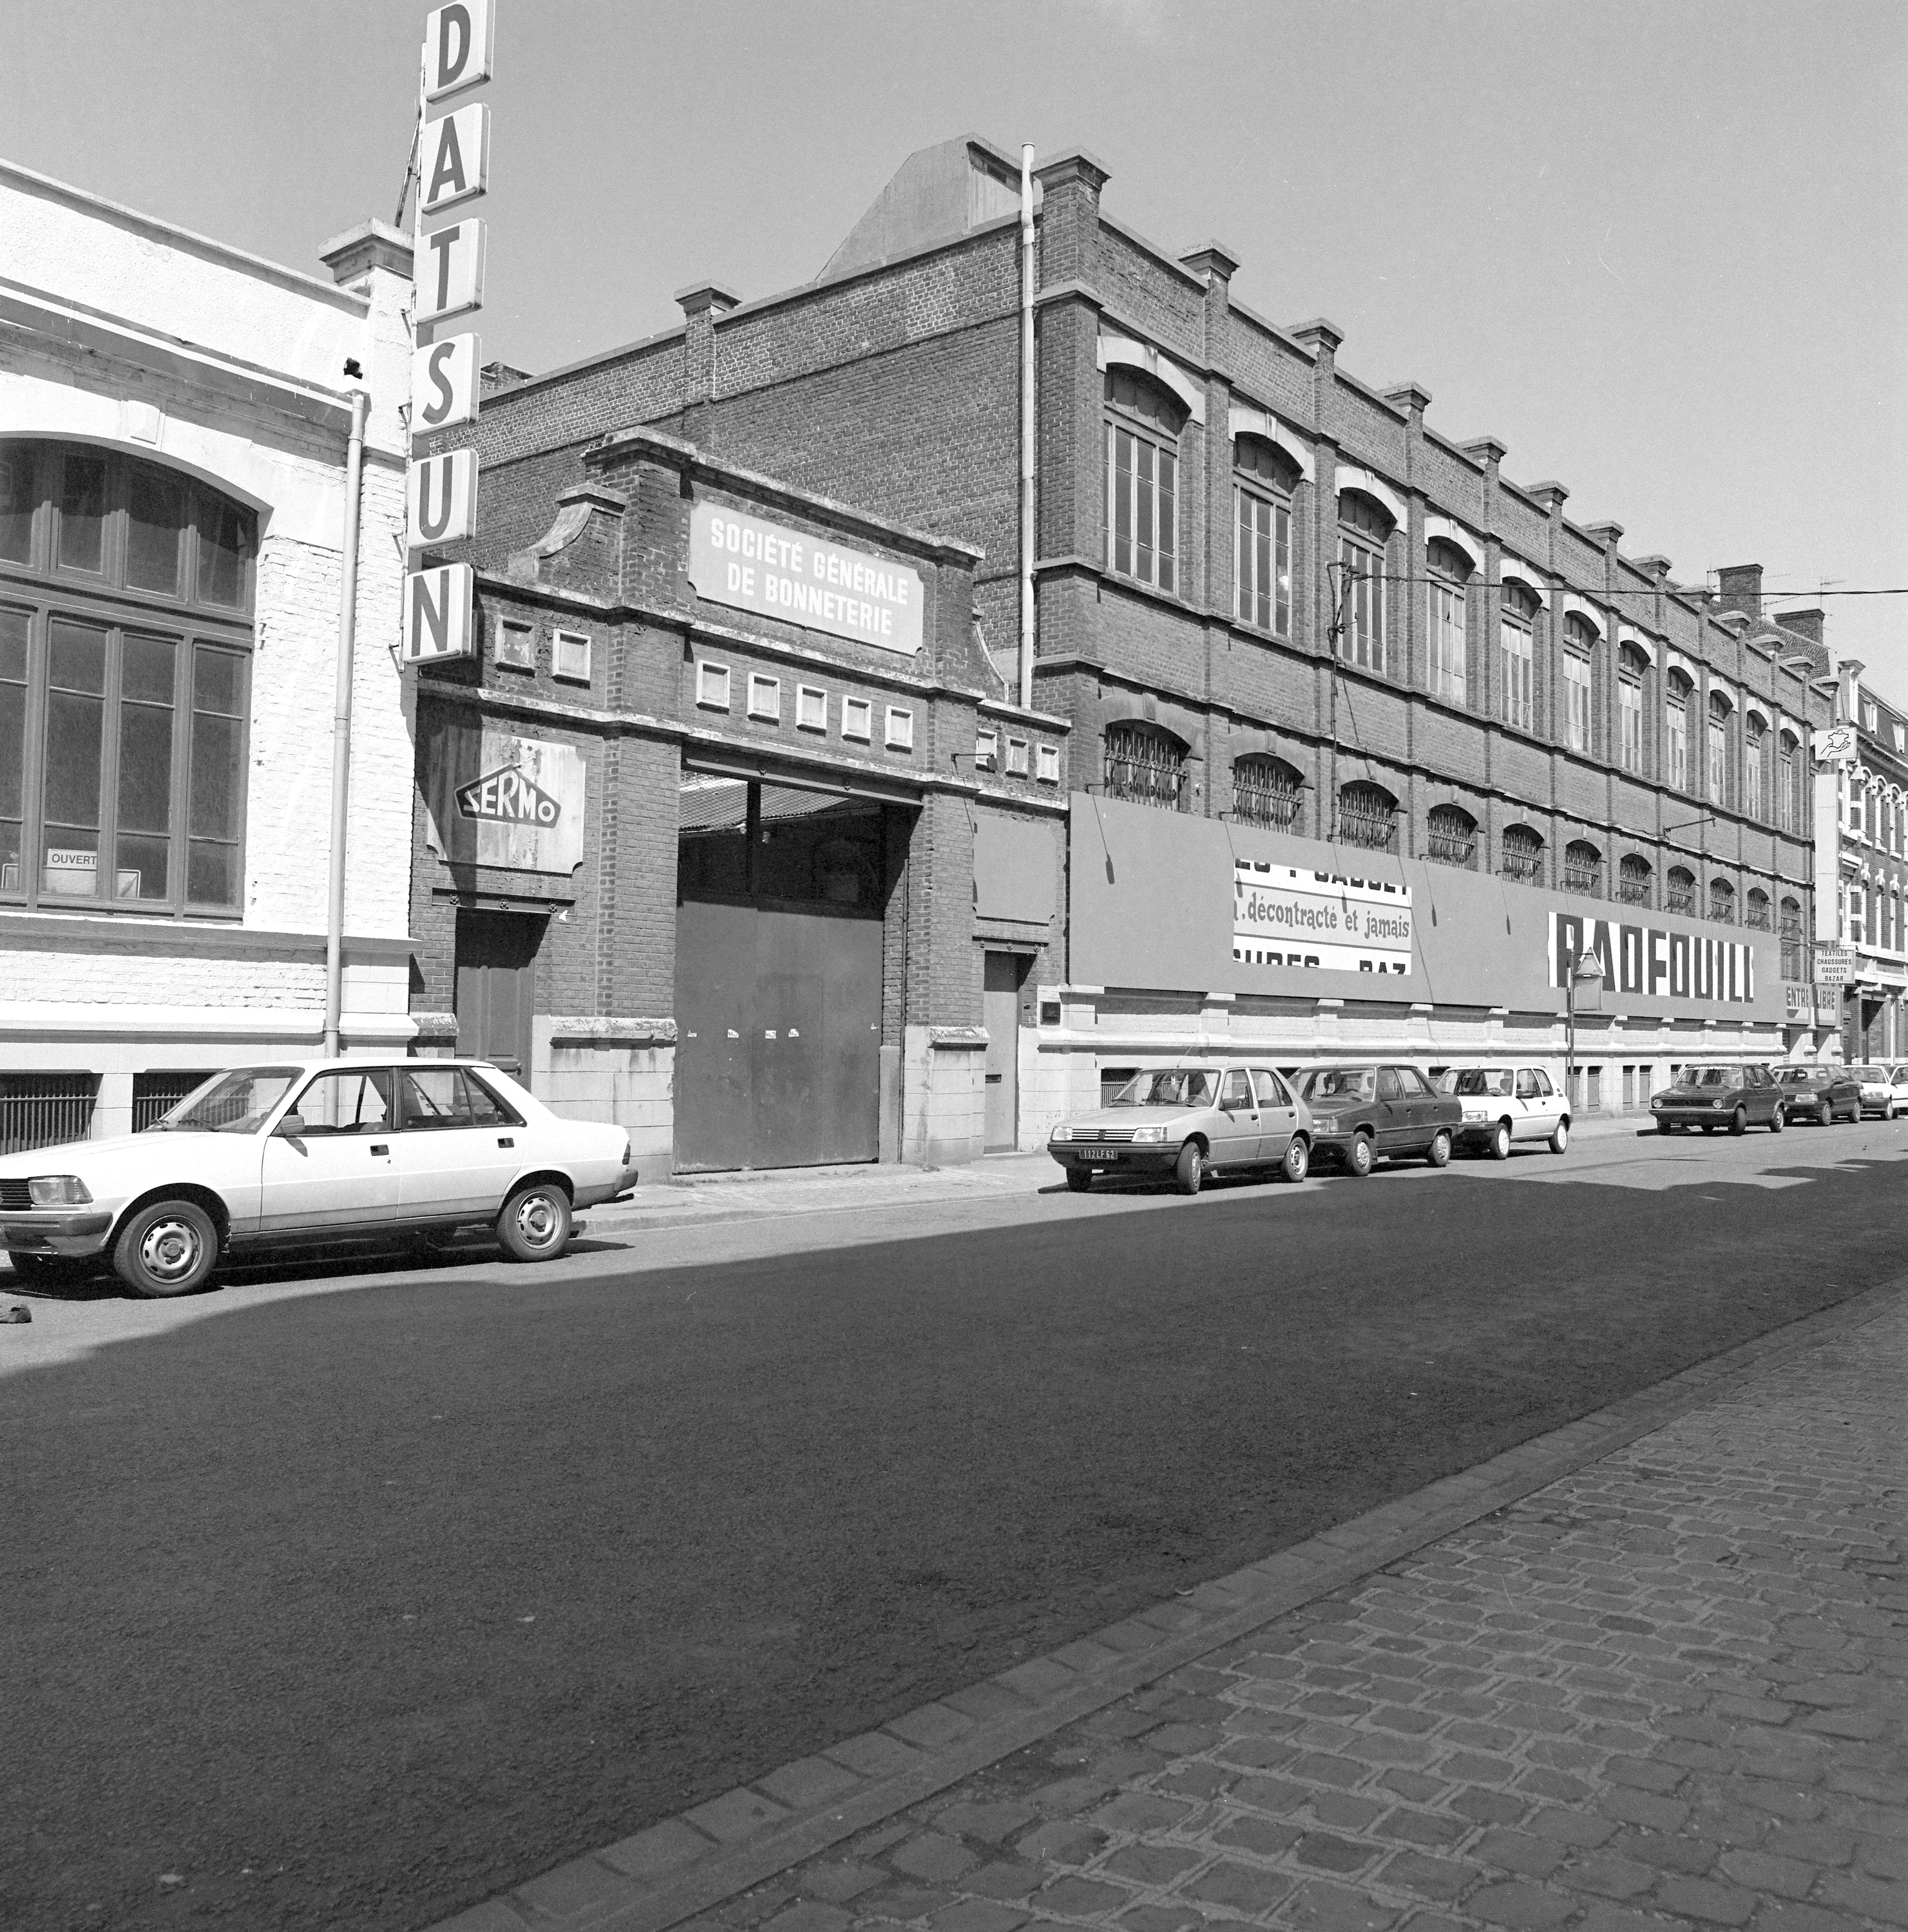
[439,137,1835,1144]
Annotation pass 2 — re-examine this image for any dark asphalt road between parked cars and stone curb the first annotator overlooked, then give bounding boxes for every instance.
[0,1126,1908,1932]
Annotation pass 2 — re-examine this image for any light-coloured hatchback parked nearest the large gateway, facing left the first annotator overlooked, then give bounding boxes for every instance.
[1048,1065,1313,1194]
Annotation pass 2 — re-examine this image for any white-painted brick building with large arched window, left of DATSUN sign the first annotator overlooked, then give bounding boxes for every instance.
[0,166,414,1148]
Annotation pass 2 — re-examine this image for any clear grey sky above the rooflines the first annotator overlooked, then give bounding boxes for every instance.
[11,0,1908,701]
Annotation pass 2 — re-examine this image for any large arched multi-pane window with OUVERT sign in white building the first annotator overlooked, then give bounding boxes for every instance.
[0,442,257,914]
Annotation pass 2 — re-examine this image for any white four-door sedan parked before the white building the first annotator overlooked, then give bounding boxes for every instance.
[0,1059,636,1294]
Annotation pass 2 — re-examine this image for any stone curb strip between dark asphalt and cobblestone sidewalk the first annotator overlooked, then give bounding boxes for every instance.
[429,1275,1908,1932]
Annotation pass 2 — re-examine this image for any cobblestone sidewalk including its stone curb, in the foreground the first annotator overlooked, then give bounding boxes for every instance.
[443,1279,1908,1932]
